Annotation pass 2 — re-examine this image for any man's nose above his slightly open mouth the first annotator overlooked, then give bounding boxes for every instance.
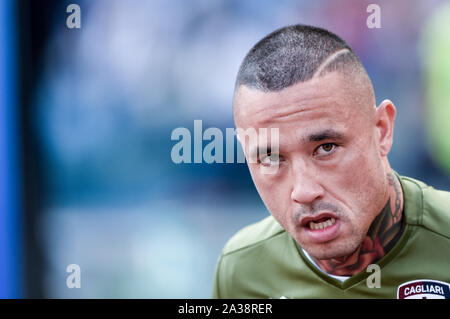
[291,163,325,205]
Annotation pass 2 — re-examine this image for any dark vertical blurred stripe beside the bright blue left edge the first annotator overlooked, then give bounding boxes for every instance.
[12,0,65,298]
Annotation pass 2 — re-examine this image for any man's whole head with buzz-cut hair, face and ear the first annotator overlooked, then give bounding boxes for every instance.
[233,25,395,259]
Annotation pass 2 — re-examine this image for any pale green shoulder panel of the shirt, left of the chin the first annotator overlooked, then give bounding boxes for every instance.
[222,216,285,255]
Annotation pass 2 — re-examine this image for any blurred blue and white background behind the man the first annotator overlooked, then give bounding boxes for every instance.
[0,0,450,298]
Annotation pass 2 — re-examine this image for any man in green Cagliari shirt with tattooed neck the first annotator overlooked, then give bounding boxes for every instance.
[213,25,450,298]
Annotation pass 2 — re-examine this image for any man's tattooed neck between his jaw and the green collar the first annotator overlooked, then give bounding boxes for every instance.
[313,172,403,276]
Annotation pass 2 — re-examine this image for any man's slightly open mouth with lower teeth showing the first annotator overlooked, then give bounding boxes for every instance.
[300,213,341,243]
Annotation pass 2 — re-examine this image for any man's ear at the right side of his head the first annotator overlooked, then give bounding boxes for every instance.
[375,100,397,156]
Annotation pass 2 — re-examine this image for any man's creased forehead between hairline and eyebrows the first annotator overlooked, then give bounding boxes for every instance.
[234,72,364,130]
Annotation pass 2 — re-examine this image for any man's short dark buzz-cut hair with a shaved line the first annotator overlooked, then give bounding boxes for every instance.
[235,24,373,92]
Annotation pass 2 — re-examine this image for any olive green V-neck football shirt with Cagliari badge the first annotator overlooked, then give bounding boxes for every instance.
[213,177,450,298]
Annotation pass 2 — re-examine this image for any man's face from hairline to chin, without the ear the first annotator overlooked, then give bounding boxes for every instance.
[234,72,395,259]
